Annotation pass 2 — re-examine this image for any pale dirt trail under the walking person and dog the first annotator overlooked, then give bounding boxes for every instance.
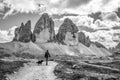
[8,61,57,80]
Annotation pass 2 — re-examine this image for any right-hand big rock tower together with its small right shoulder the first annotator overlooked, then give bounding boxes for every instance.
[56,18,91,47]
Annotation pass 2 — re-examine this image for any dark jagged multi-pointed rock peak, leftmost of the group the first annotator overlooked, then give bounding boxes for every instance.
[13,20,33,42]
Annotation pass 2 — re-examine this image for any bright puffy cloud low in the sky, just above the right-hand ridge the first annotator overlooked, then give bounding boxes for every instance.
[83,30,120,48]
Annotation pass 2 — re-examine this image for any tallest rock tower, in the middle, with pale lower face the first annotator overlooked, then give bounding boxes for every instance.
[33,13,55,43]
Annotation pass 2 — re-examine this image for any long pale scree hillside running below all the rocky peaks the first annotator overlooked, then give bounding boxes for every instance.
[0,42,111,57]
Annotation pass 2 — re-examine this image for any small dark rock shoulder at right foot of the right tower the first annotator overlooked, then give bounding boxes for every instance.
[78,32,91,47]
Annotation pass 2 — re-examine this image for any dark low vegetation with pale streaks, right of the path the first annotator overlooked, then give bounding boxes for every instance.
[54,58,120,80]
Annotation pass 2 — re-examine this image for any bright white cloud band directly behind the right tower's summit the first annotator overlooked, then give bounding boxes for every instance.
[59,13,120,30]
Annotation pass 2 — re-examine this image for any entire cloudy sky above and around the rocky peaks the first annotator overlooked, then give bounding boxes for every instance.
[0,0,120,47]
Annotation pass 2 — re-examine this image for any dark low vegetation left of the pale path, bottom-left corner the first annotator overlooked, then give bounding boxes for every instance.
[0,60,27,80]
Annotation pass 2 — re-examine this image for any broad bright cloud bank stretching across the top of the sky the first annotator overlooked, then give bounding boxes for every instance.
[0,0,120,18]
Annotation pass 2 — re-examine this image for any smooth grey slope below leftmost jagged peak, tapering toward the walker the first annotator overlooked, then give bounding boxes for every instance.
[0,42,44,57]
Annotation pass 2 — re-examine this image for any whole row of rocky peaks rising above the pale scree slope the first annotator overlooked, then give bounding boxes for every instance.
[13,13,105,48]
